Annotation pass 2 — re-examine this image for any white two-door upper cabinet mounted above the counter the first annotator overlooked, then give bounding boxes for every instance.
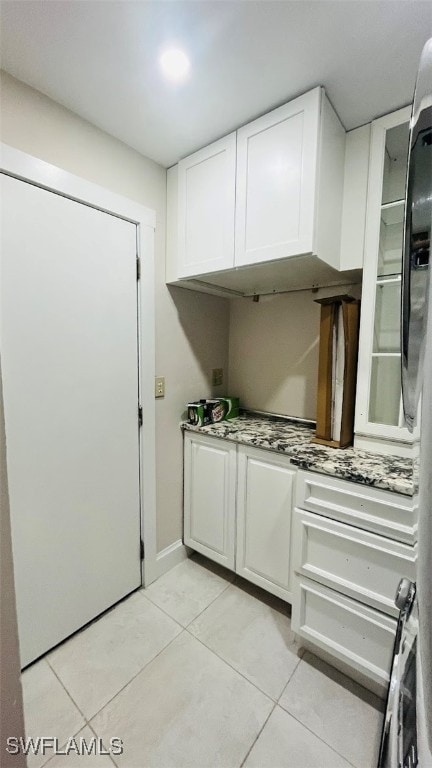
[166,88,364,295]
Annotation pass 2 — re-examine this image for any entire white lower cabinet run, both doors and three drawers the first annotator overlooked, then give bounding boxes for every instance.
[184,432,417,694]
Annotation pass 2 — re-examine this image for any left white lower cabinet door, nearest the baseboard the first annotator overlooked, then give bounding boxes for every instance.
[184,433,236,570]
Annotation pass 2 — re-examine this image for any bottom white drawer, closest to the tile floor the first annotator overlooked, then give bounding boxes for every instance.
[291,576,396,686]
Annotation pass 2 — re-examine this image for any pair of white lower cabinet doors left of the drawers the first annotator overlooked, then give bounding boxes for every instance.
[184,432,296,601]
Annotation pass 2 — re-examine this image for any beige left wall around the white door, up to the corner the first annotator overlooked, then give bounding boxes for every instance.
[0,72,228,551]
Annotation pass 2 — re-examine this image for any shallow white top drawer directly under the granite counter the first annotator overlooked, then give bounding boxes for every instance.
[296,472,417,544]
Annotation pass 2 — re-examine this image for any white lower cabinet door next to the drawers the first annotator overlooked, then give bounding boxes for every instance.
[236,446,296,600]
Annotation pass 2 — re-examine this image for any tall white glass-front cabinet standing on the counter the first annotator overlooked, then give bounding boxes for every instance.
[355,107,415,443]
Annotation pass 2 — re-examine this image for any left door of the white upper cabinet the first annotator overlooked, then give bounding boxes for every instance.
[178,133,236,278]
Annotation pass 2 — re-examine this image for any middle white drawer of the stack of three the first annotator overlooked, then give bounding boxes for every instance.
[293,509,416,617]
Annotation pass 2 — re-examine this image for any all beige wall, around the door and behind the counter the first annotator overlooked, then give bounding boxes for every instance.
[0,73,358,551]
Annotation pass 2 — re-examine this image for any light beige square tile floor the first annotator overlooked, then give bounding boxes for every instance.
[23,555,382,768]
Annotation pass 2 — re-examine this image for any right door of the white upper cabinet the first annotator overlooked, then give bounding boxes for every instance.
[235,88,321,266]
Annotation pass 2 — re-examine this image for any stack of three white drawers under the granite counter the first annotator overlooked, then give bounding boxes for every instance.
[291,472,417,693]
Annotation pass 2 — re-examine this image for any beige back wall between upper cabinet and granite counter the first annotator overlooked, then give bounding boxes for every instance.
[229,285,360,420]
